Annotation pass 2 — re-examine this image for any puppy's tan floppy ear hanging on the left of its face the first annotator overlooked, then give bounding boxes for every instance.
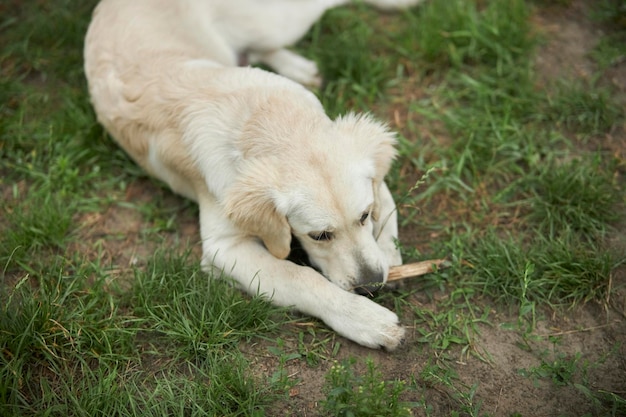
[224,158,291,259]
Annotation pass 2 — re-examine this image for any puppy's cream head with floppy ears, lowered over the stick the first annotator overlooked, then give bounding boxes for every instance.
[225,115,395,290]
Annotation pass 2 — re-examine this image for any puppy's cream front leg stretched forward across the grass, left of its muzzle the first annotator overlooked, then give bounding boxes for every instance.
[198,195,405,350]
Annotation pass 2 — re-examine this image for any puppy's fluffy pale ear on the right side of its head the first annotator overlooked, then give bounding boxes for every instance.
[335,113,397,220]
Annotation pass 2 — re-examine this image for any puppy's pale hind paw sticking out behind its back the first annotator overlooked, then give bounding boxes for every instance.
[249,49,322,87]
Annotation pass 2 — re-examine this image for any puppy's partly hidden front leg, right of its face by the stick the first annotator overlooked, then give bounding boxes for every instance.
[374,182,402,266]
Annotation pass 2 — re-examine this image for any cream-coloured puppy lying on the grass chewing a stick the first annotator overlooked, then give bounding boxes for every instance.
[80,0,416,349]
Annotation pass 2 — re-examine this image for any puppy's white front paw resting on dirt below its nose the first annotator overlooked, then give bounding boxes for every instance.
[325,294,405,351]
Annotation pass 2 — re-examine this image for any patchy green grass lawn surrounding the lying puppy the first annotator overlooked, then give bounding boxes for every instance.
[0,0,626,416]
